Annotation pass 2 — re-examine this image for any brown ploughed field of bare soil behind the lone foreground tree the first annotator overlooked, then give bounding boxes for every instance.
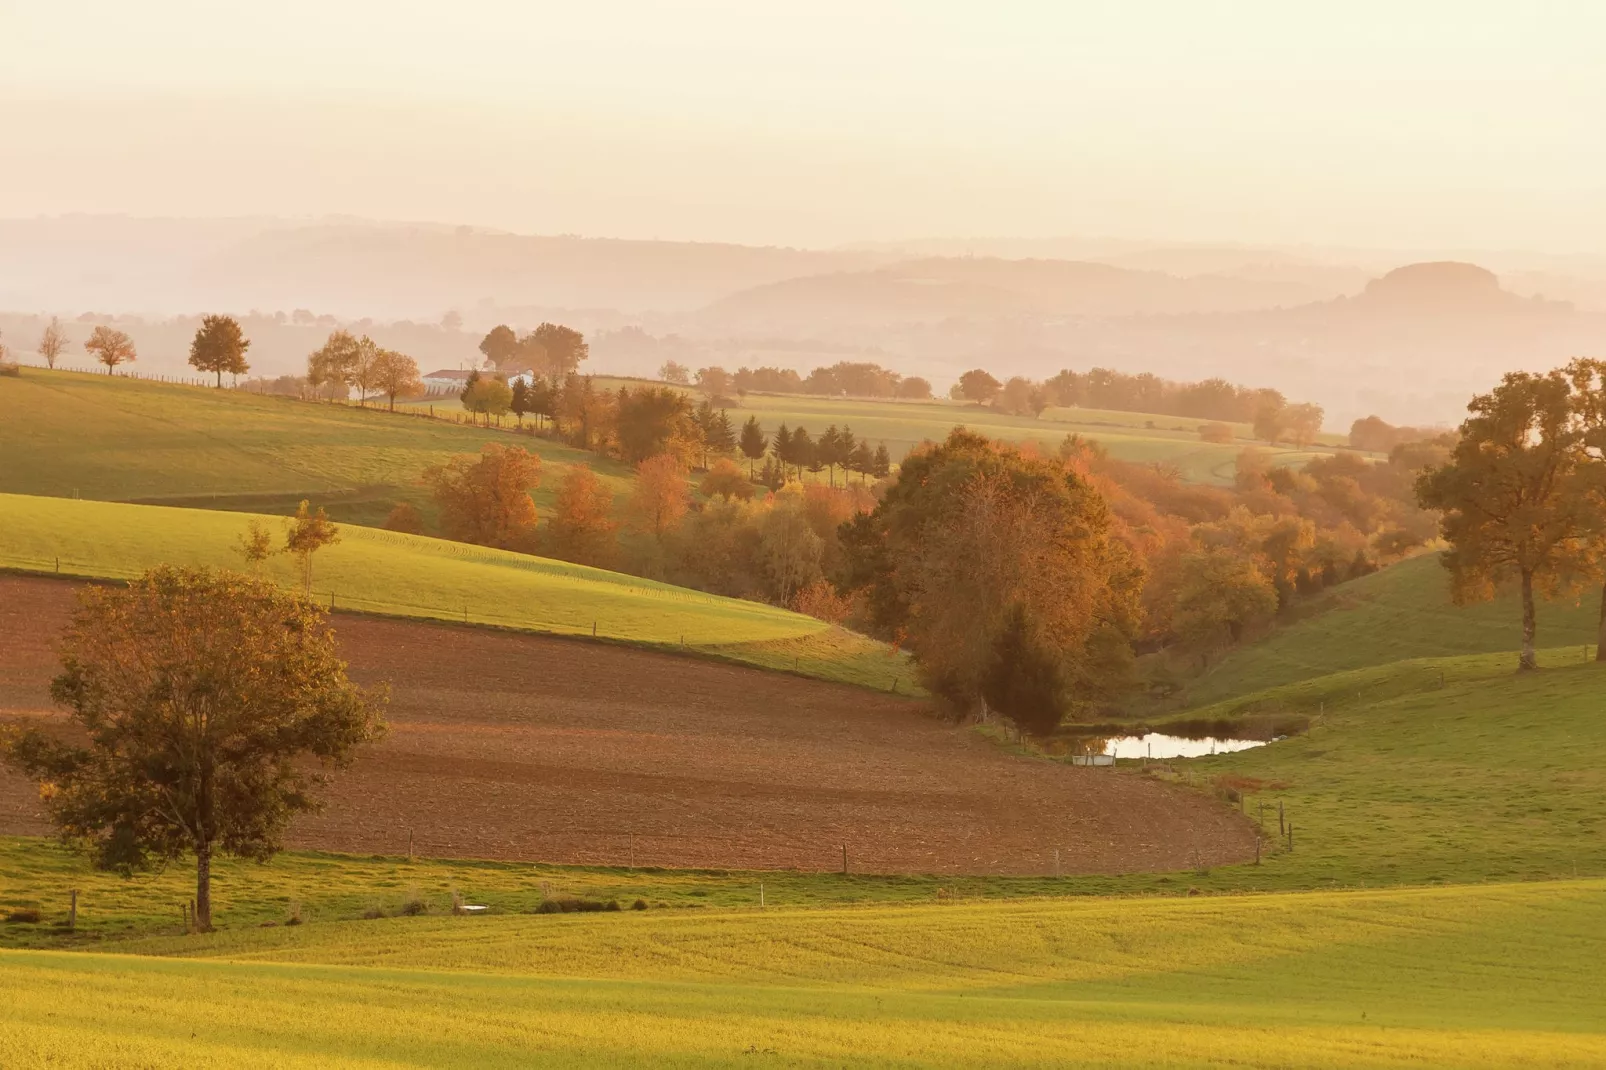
[0,577,1254,874]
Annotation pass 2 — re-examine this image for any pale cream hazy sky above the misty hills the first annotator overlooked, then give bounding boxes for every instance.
[0,0,1606,252]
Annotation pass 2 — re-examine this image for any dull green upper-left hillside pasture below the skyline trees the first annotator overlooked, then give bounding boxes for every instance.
[0,368,628,524]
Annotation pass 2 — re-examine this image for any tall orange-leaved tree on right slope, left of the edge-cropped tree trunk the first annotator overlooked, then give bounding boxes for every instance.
[1416,371,1598,672]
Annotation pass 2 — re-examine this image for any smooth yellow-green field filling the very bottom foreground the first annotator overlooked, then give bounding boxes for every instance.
[0,882,1606,1067]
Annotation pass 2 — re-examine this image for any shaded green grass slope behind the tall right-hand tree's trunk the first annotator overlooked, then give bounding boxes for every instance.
[1187,554,1600,705]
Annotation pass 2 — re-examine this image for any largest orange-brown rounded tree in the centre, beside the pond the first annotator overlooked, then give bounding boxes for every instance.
[842,429,1142,731]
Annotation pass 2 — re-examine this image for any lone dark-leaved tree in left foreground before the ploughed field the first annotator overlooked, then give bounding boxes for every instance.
[5,567,384,932]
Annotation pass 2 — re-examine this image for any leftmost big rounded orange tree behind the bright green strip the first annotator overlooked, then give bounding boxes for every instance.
[424,443,541,549]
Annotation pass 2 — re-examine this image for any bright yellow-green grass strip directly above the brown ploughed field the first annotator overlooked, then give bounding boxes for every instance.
[0,495,909,691]
